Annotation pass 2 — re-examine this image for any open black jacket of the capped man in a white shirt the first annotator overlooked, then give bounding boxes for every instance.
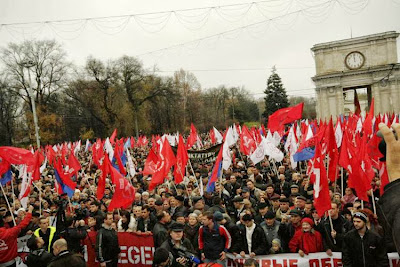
[242,224,270,255]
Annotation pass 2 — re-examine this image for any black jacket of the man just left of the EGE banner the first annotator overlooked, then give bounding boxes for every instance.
[95,226,121,262]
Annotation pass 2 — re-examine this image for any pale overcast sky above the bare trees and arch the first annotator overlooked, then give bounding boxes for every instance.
[0,0,400,98]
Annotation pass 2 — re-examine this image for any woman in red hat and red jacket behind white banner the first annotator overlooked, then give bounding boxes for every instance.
[289,217,324,257]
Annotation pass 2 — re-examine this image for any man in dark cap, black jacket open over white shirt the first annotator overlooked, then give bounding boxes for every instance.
[240,214,271,258]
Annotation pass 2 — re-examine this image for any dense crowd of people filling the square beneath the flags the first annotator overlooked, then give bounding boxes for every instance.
[0,123,400,267]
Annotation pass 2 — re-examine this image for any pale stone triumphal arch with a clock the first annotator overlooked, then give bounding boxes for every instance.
[311,31,400,119]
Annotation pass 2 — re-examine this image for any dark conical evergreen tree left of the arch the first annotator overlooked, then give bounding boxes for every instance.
[263,67,289,121]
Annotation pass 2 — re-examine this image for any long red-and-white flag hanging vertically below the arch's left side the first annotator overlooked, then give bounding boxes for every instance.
[310,144,331,217]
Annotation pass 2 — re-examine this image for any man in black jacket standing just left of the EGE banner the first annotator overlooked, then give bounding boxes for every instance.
[96,213,121,267]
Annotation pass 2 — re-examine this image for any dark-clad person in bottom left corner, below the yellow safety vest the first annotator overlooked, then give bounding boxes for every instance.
[25,235,53,267]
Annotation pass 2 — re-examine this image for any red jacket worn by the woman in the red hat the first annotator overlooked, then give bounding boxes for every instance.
[289,230,324,254]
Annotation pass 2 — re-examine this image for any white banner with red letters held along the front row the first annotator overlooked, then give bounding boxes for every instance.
[227,252,400,267]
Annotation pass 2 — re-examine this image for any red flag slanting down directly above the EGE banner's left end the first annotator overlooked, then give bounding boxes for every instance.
[108,165,136,211]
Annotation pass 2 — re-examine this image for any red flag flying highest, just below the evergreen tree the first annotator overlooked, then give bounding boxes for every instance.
[268,103,304,132]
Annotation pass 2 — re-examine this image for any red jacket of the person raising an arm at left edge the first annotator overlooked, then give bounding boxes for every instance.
[0,212,32,263]
